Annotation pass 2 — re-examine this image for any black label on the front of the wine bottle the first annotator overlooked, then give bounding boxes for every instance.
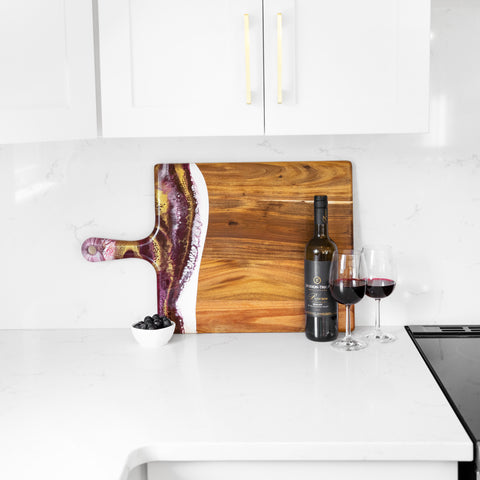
[305,260,337,317]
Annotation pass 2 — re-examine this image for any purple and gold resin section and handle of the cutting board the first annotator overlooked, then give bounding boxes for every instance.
[82,164,206,333]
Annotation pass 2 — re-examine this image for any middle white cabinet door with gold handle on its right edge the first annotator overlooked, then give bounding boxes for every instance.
[99,0,263,137]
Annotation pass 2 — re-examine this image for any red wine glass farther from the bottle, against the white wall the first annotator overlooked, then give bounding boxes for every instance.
[362,245,397,343]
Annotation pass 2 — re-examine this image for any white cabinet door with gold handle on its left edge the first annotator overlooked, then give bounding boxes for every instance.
[264,0,430,135]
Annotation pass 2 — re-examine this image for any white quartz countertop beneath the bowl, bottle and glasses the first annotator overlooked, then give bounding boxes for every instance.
[0,327,473,480]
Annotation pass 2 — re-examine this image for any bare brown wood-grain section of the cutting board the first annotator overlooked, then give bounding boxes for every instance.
[196,161,353,333]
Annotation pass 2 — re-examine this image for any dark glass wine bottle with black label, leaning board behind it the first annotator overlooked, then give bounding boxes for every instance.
[305,195,338,342]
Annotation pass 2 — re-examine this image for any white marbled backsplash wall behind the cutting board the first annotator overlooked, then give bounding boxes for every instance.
[0,0,480,328]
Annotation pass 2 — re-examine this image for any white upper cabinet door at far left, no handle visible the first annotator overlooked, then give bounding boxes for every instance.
[0,0,97,143]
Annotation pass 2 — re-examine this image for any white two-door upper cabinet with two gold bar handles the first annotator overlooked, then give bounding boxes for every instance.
[99,0,430,137]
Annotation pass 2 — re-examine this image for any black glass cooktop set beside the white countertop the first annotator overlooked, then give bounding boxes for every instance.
[405,325,480,478]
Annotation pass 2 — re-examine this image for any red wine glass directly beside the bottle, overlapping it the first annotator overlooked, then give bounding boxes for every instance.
[329,250,367,352]
